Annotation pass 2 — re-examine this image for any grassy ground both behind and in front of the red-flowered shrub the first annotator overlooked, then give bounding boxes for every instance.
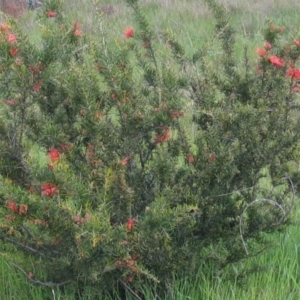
[0,0,300,300]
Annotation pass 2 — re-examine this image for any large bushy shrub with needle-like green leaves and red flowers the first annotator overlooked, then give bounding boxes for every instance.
[0,0,300,295]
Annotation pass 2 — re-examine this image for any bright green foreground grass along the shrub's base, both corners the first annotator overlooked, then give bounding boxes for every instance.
[0,224,300,300]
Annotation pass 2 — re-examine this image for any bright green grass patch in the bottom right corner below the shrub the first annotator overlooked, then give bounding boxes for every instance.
[176,226,300,300]
